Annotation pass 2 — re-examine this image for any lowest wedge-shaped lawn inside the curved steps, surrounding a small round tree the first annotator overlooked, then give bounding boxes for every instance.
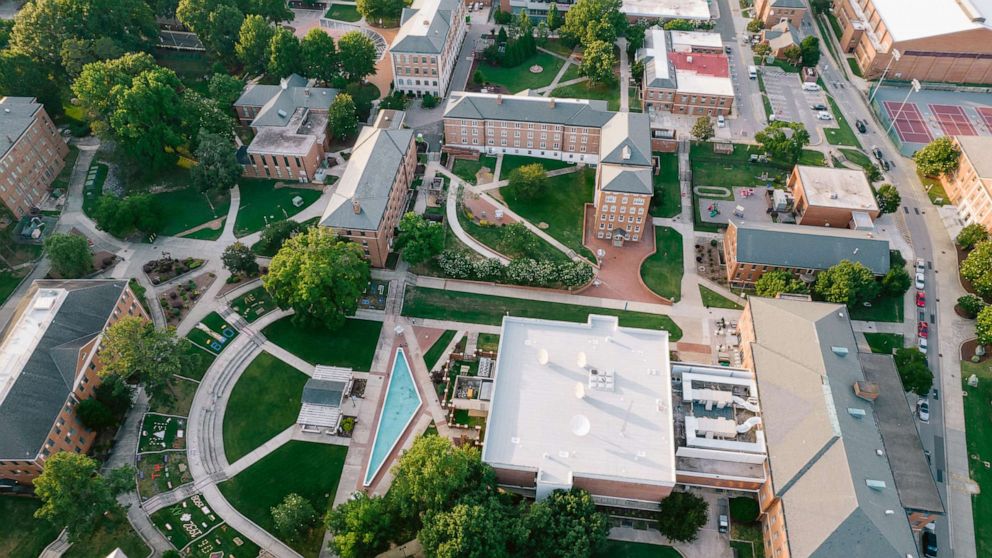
[220,441,348,557]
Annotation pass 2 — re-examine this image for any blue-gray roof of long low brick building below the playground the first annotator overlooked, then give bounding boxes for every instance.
[732,221,889,275]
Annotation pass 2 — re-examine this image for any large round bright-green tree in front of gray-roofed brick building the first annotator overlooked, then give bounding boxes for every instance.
[262,227,369,330]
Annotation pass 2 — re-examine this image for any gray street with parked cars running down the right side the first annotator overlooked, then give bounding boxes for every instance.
[814,9,975,557]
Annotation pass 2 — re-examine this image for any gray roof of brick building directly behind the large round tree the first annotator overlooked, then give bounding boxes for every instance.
[320,126,413,231]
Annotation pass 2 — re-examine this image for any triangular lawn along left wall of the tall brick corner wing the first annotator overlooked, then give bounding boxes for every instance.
[500,168,596,261]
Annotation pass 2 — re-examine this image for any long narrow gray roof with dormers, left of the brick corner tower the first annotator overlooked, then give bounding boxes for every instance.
[444,92,614,128]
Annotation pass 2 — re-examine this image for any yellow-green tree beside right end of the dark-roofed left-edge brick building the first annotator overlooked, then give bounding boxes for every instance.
[100,316,190,397]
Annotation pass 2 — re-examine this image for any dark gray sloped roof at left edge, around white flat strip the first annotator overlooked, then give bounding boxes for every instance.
[0,280,127,459]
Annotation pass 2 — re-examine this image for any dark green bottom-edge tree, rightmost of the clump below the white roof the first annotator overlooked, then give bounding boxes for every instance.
[519,488,610,558]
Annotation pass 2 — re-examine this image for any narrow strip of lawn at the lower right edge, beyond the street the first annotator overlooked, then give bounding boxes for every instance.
[961,361,992,556]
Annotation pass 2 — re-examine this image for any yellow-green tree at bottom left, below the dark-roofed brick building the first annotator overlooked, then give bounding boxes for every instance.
[34,451,134,542]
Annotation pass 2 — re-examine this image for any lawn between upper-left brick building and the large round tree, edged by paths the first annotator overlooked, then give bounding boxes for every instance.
[234,182,320,237]
